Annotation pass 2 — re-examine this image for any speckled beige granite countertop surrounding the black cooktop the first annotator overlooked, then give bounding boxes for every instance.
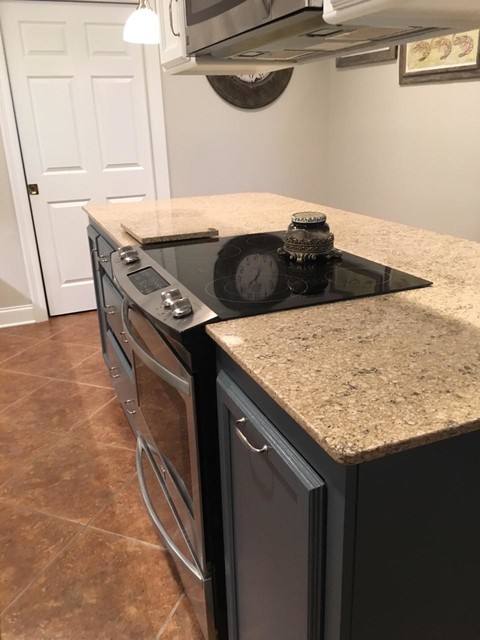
[86,193,480,464]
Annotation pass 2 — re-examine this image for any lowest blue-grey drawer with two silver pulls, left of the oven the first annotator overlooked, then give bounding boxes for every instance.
[105,329,138,433]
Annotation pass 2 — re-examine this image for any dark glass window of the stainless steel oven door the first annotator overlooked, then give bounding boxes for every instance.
[135,358,193,504]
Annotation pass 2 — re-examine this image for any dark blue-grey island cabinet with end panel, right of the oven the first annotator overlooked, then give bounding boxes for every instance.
[218,350,480,640]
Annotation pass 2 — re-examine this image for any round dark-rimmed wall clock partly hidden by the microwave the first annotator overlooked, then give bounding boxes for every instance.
[207,68,293,109]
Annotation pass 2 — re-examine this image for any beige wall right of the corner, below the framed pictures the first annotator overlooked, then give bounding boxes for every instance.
[325,56,480,240]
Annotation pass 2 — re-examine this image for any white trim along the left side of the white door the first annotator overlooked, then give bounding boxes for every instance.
[0,25,48,322]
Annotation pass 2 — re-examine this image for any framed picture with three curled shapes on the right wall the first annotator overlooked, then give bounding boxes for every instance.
[399,29,480,85]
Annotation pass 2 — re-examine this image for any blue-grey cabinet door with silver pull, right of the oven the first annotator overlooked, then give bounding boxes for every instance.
[218,372,326,640]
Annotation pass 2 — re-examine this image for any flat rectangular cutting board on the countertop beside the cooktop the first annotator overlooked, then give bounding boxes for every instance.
[121,217,218,244]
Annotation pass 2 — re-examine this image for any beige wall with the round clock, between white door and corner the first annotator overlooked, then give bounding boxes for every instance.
[163,63,327,200]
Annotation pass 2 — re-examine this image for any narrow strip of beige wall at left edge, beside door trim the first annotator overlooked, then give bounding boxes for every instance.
[0,125,31,310]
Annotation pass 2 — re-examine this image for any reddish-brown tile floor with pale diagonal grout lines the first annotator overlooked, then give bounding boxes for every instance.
[0,312,201,640]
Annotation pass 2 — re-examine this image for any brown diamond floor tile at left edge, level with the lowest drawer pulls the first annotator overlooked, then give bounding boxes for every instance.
[1,380,114,435]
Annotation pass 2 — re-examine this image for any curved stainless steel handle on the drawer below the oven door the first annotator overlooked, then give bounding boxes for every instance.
[136,435,204,581]
